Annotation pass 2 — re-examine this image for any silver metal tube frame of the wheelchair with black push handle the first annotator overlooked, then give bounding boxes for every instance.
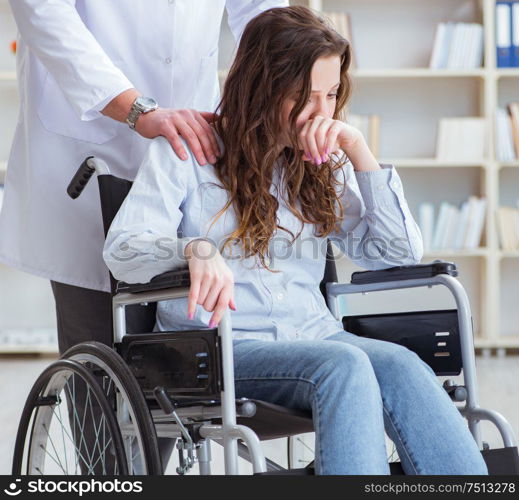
[16,157,517,475]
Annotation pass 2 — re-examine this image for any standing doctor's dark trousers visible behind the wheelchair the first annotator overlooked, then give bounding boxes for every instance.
[51,281,175,474]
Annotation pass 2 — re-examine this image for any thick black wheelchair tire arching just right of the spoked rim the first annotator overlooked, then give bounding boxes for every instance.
[62,341,163,475]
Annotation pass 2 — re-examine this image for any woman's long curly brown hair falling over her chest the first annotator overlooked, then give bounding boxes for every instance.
[213,6,351,271]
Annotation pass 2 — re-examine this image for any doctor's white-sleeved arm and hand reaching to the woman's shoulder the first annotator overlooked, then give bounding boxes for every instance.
[9,0,218,165]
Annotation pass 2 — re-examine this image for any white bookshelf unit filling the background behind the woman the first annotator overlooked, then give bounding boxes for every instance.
[0,0,519,352]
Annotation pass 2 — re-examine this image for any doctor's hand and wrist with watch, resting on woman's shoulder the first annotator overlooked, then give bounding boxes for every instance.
[102,89,220,165]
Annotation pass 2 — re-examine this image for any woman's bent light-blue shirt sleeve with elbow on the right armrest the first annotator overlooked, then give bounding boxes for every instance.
[330,150,423,270]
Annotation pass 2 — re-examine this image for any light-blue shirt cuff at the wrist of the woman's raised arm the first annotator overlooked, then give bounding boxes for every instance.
[354,163,401,210]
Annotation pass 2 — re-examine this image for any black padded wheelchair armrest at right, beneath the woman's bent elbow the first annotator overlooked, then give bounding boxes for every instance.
[351,260,458,285]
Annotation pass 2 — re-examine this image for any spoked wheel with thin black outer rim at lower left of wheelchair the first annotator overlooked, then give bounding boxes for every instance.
[13,359,128,475]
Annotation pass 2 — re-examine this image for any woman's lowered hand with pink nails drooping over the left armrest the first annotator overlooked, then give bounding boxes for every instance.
[184,240,236,328]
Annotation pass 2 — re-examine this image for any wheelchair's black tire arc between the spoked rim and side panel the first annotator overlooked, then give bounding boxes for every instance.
[62,341,163,475]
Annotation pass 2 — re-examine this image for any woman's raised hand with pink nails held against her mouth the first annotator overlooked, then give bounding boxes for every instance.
[299,115,364,165]
